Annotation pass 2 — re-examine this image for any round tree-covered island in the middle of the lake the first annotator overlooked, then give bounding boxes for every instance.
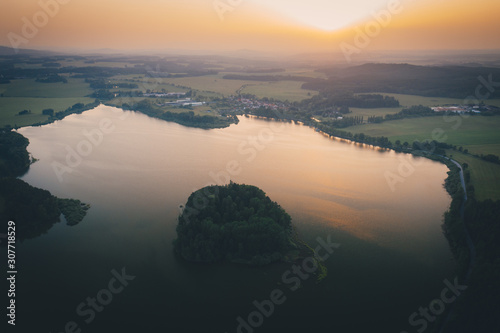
[174,183,294,265]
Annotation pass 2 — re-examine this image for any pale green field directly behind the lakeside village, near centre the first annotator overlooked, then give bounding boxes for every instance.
[241,81,318,102]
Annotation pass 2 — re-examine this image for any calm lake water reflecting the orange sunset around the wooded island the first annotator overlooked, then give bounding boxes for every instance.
[17,106,455,333]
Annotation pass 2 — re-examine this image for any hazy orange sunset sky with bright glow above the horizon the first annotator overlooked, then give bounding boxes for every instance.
[0,0,500,54]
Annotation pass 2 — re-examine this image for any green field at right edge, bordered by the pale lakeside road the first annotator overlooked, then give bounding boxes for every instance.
[446,150,500,200]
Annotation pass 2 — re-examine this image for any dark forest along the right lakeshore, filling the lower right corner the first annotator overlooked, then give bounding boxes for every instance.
[433,164,500,333]
